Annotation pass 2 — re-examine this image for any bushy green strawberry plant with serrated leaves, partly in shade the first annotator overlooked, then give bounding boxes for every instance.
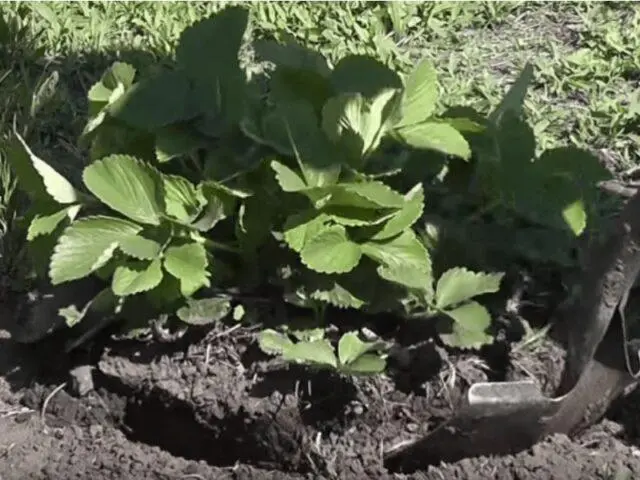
[7,7,605,373]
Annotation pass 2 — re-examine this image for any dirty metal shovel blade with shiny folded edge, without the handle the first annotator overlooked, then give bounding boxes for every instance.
[384,328,636,472]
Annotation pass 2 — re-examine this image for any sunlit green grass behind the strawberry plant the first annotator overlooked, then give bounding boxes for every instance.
[0,1,640,290]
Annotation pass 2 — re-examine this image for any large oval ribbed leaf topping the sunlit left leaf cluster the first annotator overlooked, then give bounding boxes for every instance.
[82,155,165,225]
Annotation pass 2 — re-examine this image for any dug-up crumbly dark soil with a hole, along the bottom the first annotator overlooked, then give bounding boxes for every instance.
[0,314,640,480]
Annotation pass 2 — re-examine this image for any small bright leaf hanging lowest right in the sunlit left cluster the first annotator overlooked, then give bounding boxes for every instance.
[164,243,210,297]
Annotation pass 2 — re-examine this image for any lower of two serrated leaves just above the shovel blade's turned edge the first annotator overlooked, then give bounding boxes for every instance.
[439,302,493,349]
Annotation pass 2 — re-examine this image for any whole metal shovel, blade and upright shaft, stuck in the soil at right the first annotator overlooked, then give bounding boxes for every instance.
[384,188,640,472]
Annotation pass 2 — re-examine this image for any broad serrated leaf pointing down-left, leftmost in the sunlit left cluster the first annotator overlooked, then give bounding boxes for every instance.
[49,216,142,285]
